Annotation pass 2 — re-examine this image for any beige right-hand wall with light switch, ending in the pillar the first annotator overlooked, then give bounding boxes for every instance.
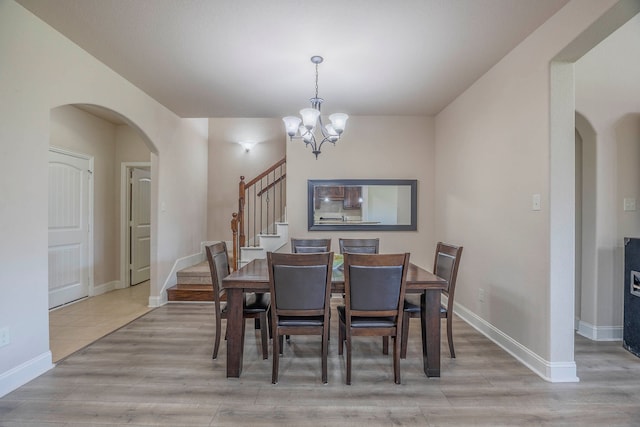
[435,1,615,381]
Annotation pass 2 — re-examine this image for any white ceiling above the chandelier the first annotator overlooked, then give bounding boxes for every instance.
[17,0,568,117]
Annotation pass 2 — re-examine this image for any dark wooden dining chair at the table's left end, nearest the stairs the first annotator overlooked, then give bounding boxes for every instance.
[205,242,270,359]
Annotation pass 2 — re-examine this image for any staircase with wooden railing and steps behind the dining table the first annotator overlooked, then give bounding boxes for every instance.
[167,159,289,302]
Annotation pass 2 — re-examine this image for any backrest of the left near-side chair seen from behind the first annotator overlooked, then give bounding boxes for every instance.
[267,252,333,322]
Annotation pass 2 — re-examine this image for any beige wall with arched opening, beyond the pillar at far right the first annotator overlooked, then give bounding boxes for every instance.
[575,15,640,339]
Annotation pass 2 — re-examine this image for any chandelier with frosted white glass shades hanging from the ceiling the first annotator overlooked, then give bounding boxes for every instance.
[282,56,349,159]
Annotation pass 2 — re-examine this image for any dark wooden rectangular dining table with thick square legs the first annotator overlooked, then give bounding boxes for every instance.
[222,259,447,378]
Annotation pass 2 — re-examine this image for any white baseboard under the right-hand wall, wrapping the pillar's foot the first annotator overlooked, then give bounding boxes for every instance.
[454,303,580,383]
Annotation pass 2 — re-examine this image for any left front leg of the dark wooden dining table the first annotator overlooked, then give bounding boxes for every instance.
[227,289,245,378]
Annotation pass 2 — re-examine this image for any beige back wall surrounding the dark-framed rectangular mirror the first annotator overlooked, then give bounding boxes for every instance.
[287,116,435,269]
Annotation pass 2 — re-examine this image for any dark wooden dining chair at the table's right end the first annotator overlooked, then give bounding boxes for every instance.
[400,242,462,359]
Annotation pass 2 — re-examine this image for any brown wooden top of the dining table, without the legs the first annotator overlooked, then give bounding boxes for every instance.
[222,259,447,292]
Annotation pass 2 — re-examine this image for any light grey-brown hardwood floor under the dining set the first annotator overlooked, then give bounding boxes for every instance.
[0,304,640,427]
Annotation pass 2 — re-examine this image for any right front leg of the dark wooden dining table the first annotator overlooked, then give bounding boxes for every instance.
[420,289,440,377]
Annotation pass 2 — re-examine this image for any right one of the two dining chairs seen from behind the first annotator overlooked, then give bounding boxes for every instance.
[338,252,409,384]
